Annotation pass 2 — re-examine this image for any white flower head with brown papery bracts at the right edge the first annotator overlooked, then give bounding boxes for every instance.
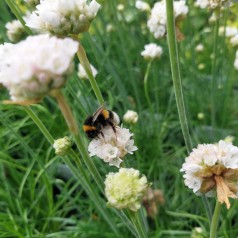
[181,140,238,208]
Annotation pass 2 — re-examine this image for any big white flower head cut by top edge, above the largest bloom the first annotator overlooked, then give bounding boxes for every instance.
[26,0,100,36]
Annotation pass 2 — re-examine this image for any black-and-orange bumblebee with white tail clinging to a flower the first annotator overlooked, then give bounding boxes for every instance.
[83,106,120,140]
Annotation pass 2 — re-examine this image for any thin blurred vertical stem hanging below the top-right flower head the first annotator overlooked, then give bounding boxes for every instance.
[211,10,220,127]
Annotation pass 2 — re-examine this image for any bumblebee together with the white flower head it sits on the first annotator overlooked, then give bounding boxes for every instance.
[83,107,137,168]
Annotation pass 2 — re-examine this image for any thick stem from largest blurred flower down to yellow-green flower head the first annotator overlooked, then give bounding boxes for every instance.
[52,90,104,193]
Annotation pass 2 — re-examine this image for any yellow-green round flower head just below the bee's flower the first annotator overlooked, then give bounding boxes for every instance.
[104,168,149,212]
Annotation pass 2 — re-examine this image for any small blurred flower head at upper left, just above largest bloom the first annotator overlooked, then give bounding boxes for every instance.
[5,20,26,42]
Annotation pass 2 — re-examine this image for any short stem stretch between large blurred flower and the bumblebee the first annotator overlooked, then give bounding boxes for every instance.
[77,43,104,105]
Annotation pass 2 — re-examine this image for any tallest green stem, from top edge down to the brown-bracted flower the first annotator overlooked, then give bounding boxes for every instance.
[166,0,192,153]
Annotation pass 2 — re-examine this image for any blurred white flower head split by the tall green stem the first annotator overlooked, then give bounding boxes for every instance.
[147,0,188,39]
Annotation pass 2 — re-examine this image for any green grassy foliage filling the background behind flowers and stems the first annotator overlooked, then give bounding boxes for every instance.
[0,0,238,238]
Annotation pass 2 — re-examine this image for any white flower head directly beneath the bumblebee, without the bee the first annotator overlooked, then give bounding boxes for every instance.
[88,126,137,168]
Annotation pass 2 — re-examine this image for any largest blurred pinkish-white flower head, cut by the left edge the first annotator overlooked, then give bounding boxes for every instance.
[0,35,78,102]
